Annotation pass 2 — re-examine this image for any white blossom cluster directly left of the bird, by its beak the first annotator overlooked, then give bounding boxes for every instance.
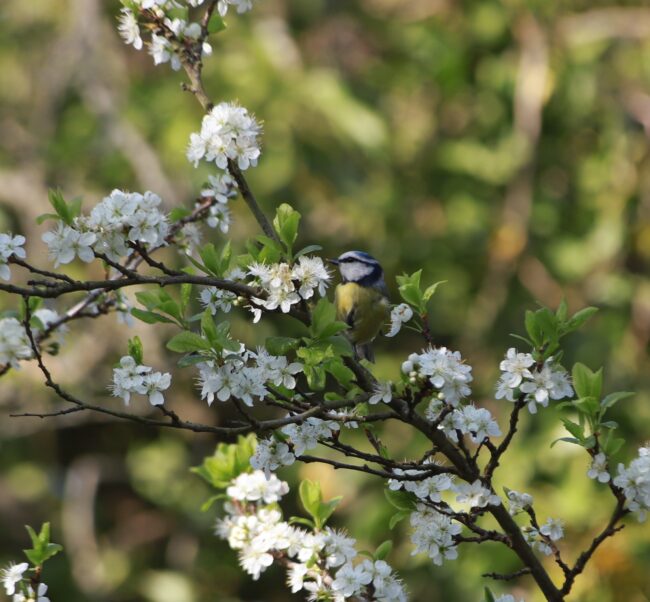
[248,255,331,313]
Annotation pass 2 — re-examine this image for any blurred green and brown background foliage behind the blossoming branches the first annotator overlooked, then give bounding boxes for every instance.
[0,0,650,602]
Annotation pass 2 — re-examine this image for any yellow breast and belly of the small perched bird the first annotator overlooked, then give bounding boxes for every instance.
[334,282,389,344]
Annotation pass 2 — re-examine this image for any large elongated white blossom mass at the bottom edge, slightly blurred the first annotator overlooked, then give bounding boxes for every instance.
[216,471,406,602]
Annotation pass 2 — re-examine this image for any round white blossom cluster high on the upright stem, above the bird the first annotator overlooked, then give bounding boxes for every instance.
[187,102,262,170]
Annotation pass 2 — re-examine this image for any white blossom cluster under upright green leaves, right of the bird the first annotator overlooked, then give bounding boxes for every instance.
[496,347,573,414]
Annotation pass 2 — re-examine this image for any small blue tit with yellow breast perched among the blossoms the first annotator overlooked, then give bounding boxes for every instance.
[330,251,390,362]
